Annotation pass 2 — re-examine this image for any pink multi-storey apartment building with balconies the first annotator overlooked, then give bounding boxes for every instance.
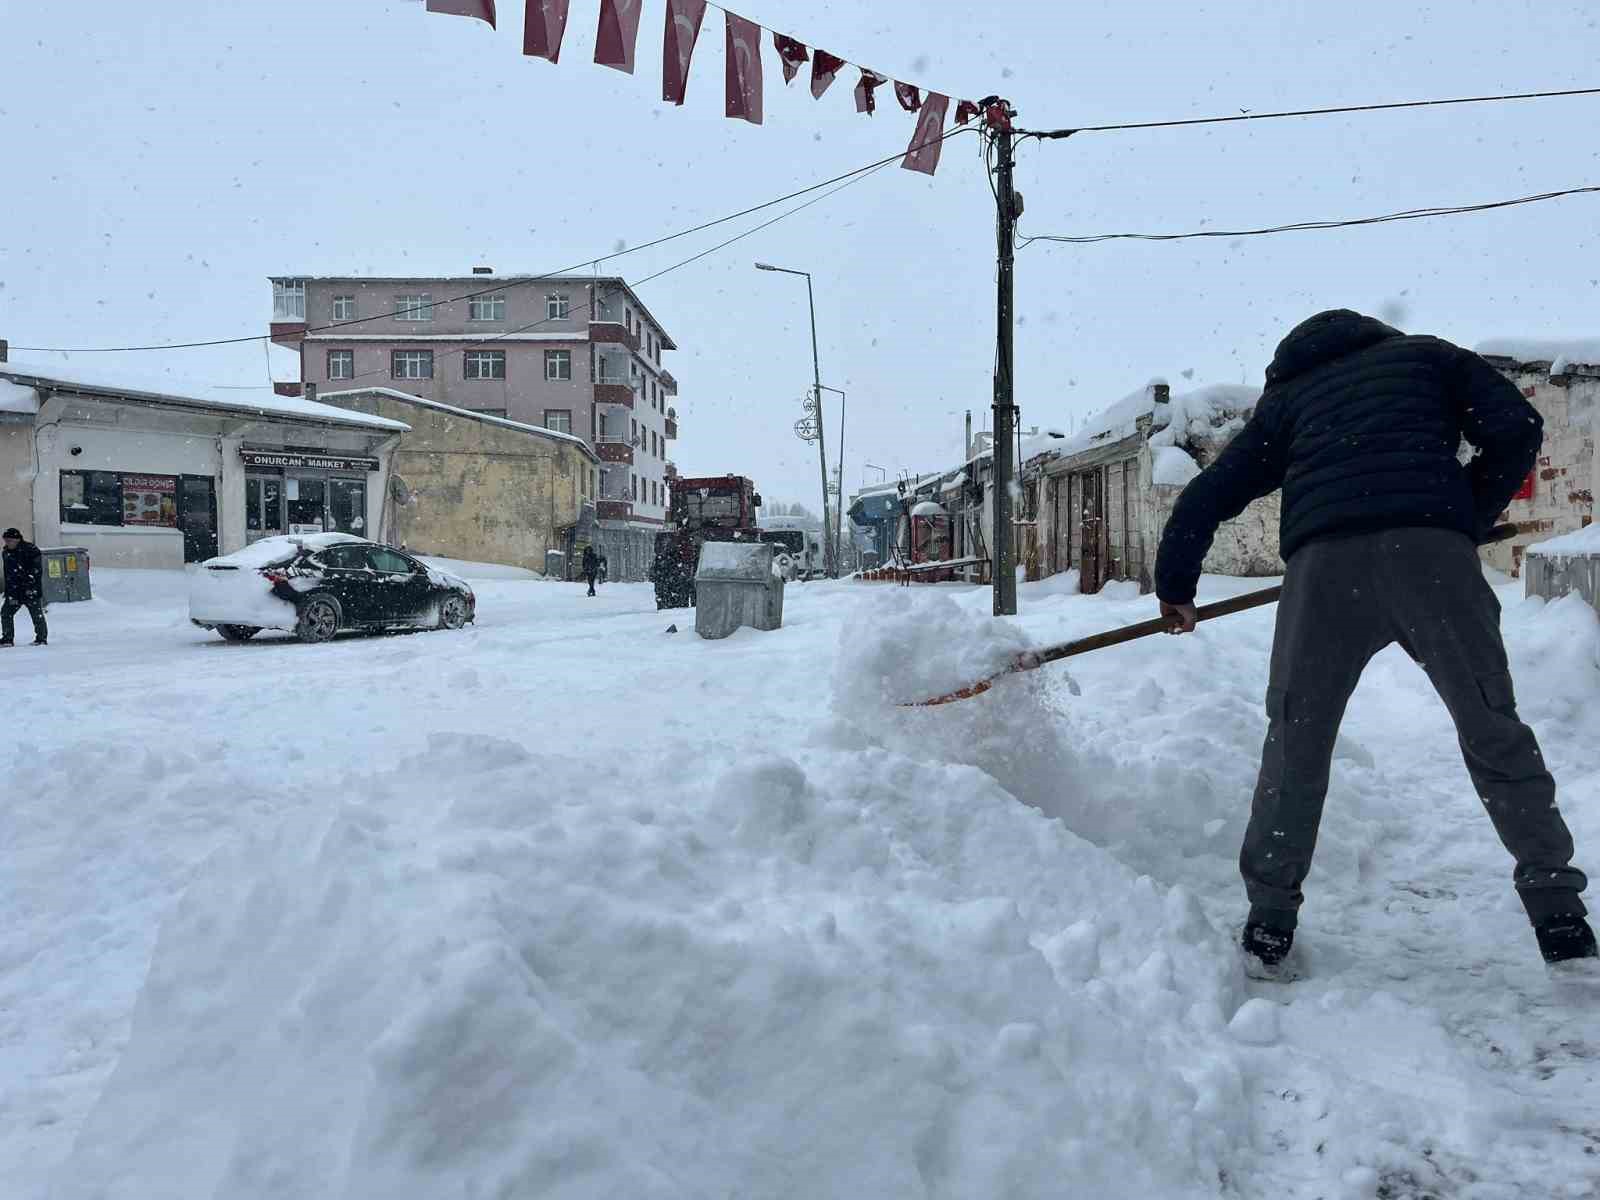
[272,267,678,578]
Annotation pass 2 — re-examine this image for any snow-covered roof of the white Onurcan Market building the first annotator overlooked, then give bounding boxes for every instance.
[0,362,410,434]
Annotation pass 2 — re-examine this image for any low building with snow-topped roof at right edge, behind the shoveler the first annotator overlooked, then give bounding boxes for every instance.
[1478,339,1600,574]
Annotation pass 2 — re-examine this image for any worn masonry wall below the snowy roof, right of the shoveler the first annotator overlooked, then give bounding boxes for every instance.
[1482,358,1600,574]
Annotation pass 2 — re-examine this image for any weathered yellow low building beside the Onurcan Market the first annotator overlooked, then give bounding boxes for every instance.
[330,392,595,571]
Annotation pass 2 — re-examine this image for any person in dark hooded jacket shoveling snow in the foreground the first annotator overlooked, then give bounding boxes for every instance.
[1155,309,1595,973]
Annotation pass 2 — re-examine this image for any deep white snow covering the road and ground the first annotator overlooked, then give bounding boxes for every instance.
[0,571,1600,1200]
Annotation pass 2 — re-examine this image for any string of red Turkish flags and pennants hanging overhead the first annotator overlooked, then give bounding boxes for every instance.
[426,0,982,174]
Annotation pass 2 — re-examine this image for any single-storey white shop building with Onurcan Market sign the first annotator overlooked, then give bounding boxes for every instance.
[0,363,408,568]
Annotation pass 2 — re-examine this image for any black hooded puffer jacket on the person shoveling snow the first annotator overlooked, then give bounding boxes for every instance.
[1155,309,1544,605]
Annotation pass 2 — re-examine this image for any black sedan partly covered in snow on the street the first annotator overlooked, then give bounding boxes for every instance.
[189,533,477,642]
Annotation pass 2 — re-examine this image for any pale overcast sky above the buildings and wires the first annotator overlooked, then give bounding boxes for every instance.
[0,0,1600,507]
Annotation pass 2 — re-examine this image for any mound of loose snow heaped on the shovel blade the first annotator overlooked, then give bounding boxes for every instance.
[834,589,1029,722]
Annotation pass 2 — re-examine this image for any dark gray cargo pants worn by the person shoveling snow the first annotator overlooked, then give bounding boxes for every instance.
[1238,528,1587,930]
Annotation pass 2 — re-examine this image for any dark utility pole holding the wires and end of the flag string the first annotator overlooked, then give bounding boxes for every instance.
[984,96,1022,616]
